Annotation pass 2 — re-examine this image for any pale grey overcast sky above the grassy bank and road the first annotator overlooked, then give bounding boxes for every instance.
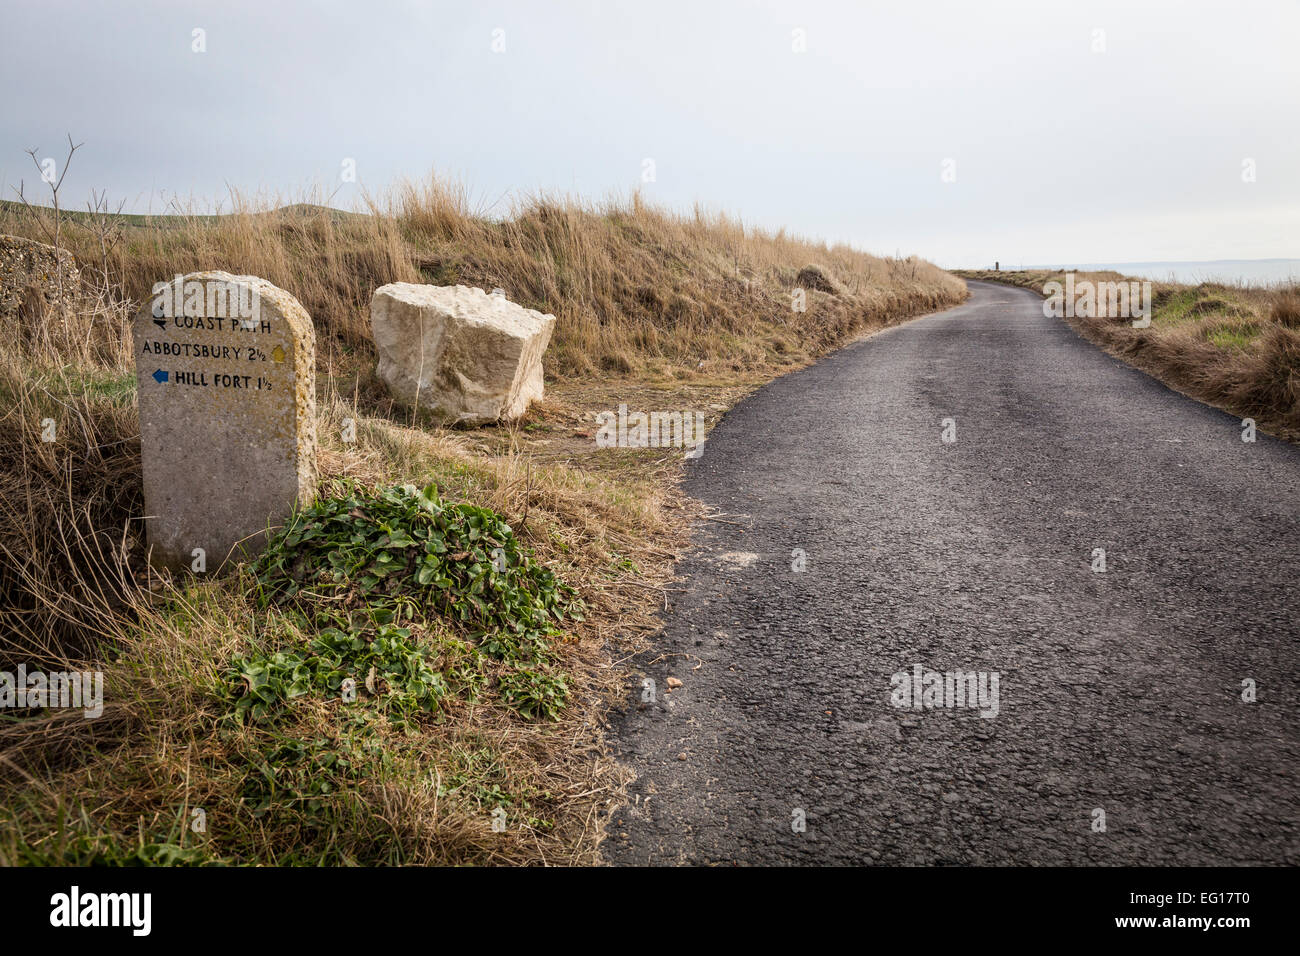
[0,0,1300,268]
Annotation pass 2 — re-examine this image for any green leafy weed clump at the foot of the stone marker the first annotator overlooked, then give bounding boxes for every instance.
[226,481,582,723]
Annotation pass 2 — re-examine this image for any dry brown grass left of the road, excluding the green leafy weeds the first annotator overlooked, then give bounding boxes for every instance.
[0,183,965,864]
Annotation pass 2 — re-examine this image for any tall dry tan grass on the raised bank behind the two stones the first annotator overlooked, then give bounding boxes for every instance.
[0,178,965,378]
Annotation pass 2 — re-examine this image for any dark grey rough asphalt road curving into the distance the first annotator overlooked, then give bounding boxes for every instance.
[605,282,1300,865]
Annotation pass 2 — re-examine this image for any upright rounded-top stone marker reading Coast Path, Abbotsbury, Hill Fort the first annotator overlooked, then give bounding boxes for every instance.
[134,272,316,572]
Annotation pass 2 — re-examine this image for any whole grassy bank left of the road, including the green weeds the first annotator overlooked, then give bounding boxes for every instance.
[0,183,965,864]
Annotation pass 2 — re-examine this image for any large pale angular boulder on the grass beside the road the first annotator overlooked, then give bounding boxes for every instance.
[371,282,555,424]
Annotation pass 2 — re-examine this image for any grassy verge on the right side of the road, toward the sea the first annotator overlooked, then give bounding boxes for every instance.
[956,271,1300,441]
